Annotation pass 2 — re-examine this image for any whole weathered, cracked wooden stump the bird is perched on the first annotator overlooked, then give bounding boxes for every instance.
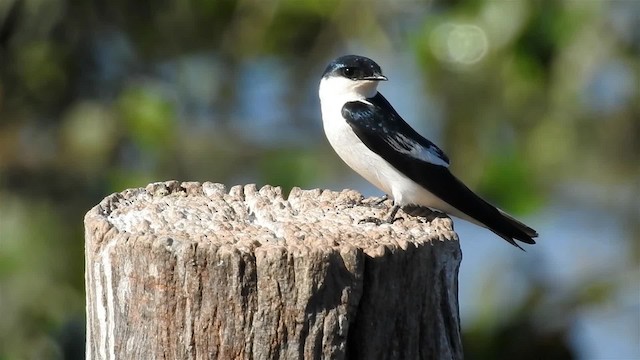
[85,181,462,359]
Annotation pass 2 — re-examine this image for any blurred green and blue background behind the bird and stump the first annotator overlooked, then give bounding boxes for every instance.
[0,0,640,360]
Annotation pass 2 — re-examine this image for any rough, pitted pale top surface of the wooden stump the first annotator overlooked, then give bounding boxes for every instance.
[85,181,458,256]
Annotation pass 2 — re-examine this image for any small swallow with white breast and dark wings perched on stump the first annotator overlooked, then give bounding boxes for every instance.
[318,55,538,250]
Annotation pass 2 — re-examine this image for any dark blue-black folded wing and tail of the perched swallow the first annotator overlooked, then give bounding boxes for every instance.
[342,93,538,247]
